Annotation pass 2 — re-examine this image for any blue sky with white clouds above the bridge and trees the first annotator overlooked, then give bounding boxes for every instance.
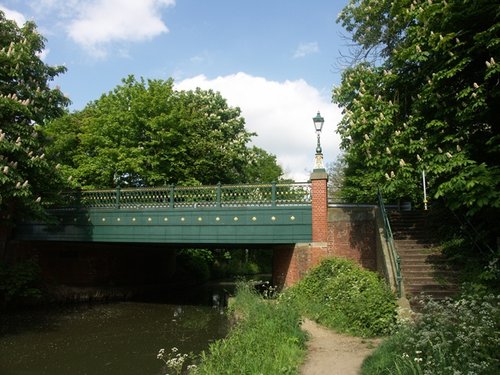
[0,0,349,181]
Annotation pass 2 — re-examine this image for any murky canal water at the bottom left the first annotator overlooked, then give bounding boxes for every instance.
[0,298,228,375]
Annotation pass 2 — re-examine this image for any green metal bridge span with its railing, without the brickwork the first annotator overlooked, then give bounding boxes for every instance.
[15,183,312,245]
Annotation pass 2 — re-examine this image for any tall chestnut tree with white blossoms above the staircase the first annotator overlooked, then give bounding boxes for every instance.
[333,0,500,215]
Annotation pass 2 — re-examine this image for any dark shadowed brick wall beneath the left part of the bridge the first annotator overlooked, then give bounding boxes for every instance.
[13,241,175,286]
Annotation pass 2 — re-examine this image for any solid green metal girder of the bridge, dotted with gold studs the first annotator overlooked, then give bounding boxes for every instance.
[15,205,312,245]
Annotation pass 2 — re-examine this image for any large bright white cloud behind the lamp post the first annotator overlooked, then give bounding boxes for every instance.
[175,72,341,181]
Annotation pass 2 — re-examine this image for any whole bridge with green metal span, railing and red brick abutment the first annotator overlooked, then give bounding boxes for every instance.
[12,173,394,285]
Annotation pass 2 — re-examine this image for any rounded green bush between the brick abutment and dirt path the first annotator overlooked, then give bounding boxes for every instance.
[285,258,396,336]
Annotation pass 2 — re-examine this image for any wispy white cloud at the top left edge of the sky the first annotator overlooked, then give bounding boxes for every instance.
[68,0,175,56]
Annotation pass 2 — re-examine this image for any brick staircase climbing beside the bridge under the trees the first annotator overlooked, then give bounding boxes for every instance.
[388,211,458,301]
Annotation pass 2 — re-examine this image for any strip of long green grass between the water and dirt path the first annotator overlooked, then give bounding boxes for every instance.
[194,283,306,375]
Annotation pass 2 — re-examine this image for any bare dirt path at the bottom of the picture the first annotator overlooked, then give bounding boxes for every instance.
[301,319,380,375]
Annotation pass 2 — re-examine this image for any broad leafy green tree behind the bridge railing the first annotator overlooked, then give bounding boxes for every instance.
[46,76,282,188]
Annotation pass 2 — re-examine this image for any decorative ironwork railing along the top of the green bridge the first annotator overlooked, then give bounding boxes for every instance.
[50,183,311,208]
